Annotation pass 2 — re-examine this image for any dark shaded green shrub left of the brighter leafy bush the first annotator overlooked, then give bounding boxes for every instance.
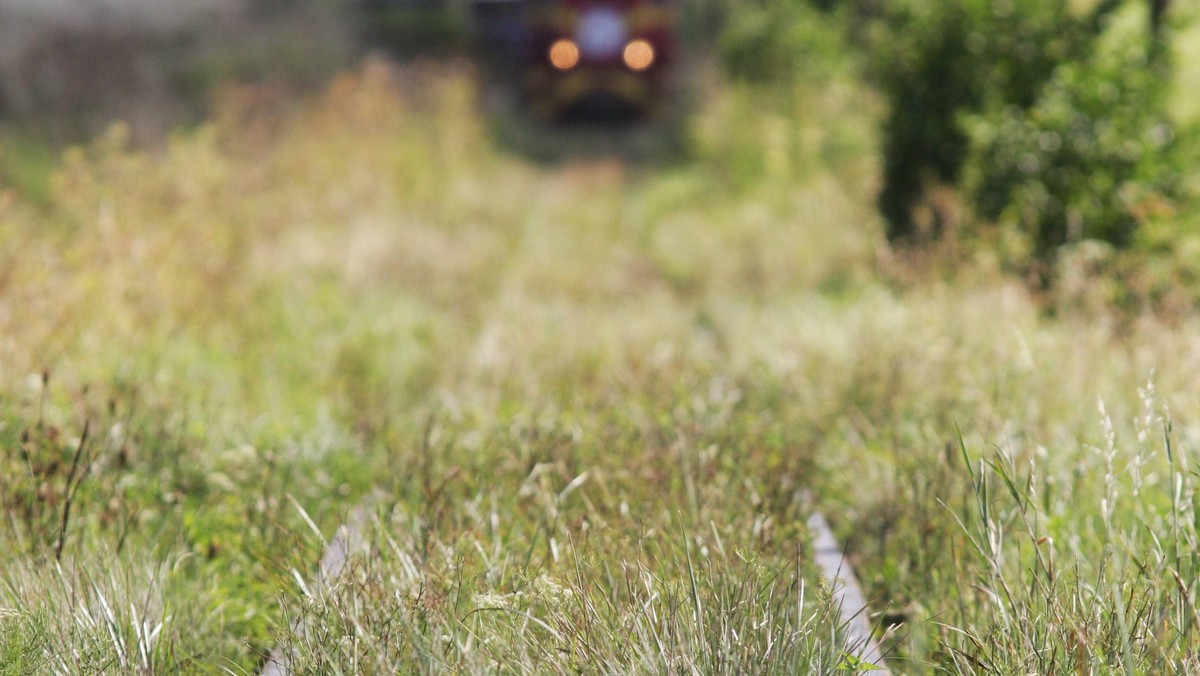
[874,0,1117,241]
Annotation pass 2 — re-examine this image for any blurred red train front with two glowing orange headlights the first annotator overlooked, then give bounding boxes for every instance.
[524,0,676,118]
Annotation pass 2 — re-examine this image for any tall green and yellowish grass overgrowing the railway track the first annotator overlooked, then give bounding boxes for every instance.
[0,50,1200,674]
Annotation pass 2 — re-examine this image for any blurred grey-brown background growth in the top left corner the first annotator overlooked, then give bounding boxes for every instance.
[0,0,359,144]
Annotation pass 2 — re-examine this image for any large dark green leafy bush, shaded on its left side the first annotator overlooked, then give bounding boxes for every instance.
[875,0,1178,259]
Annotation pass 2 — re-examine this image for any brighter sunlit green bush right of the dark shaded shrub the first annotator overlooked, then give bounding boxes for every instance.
[966,29,1180,258]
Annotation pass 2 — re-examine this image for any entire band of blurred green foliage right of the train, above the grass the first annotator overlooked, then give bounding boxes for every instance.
[718,0,1200,296]
